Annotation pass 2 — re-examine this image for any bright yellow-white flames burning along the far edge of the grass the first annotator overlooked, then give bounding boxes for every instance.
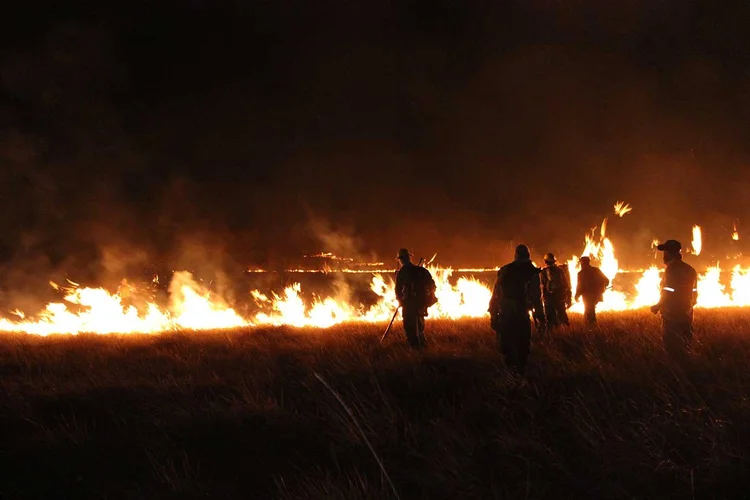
[0,202,750,335]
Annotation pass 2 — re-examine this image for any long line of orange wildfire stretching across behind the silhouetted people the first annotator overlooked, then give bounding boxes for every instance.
[0,202,750,335]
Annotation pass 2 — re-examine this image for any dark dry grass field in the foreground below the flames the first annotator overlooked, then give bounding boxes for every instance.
[0,309,750,499]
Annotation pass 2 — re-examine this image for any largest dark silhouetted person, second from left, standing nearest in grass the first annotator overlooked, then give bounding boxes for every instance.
[489,245,546,376]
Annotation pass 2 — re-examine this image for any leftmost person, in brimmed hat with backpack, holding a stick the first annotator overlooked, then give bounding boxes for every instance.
[396,248,437,349]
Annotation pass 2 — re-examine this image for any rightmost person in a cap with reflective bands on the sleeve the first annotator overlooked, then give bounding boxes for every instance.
[651,240,698,356]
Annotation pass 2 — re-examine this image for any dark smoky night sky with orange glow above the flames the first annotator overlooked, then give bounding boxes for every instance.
[0,0,750,283]
